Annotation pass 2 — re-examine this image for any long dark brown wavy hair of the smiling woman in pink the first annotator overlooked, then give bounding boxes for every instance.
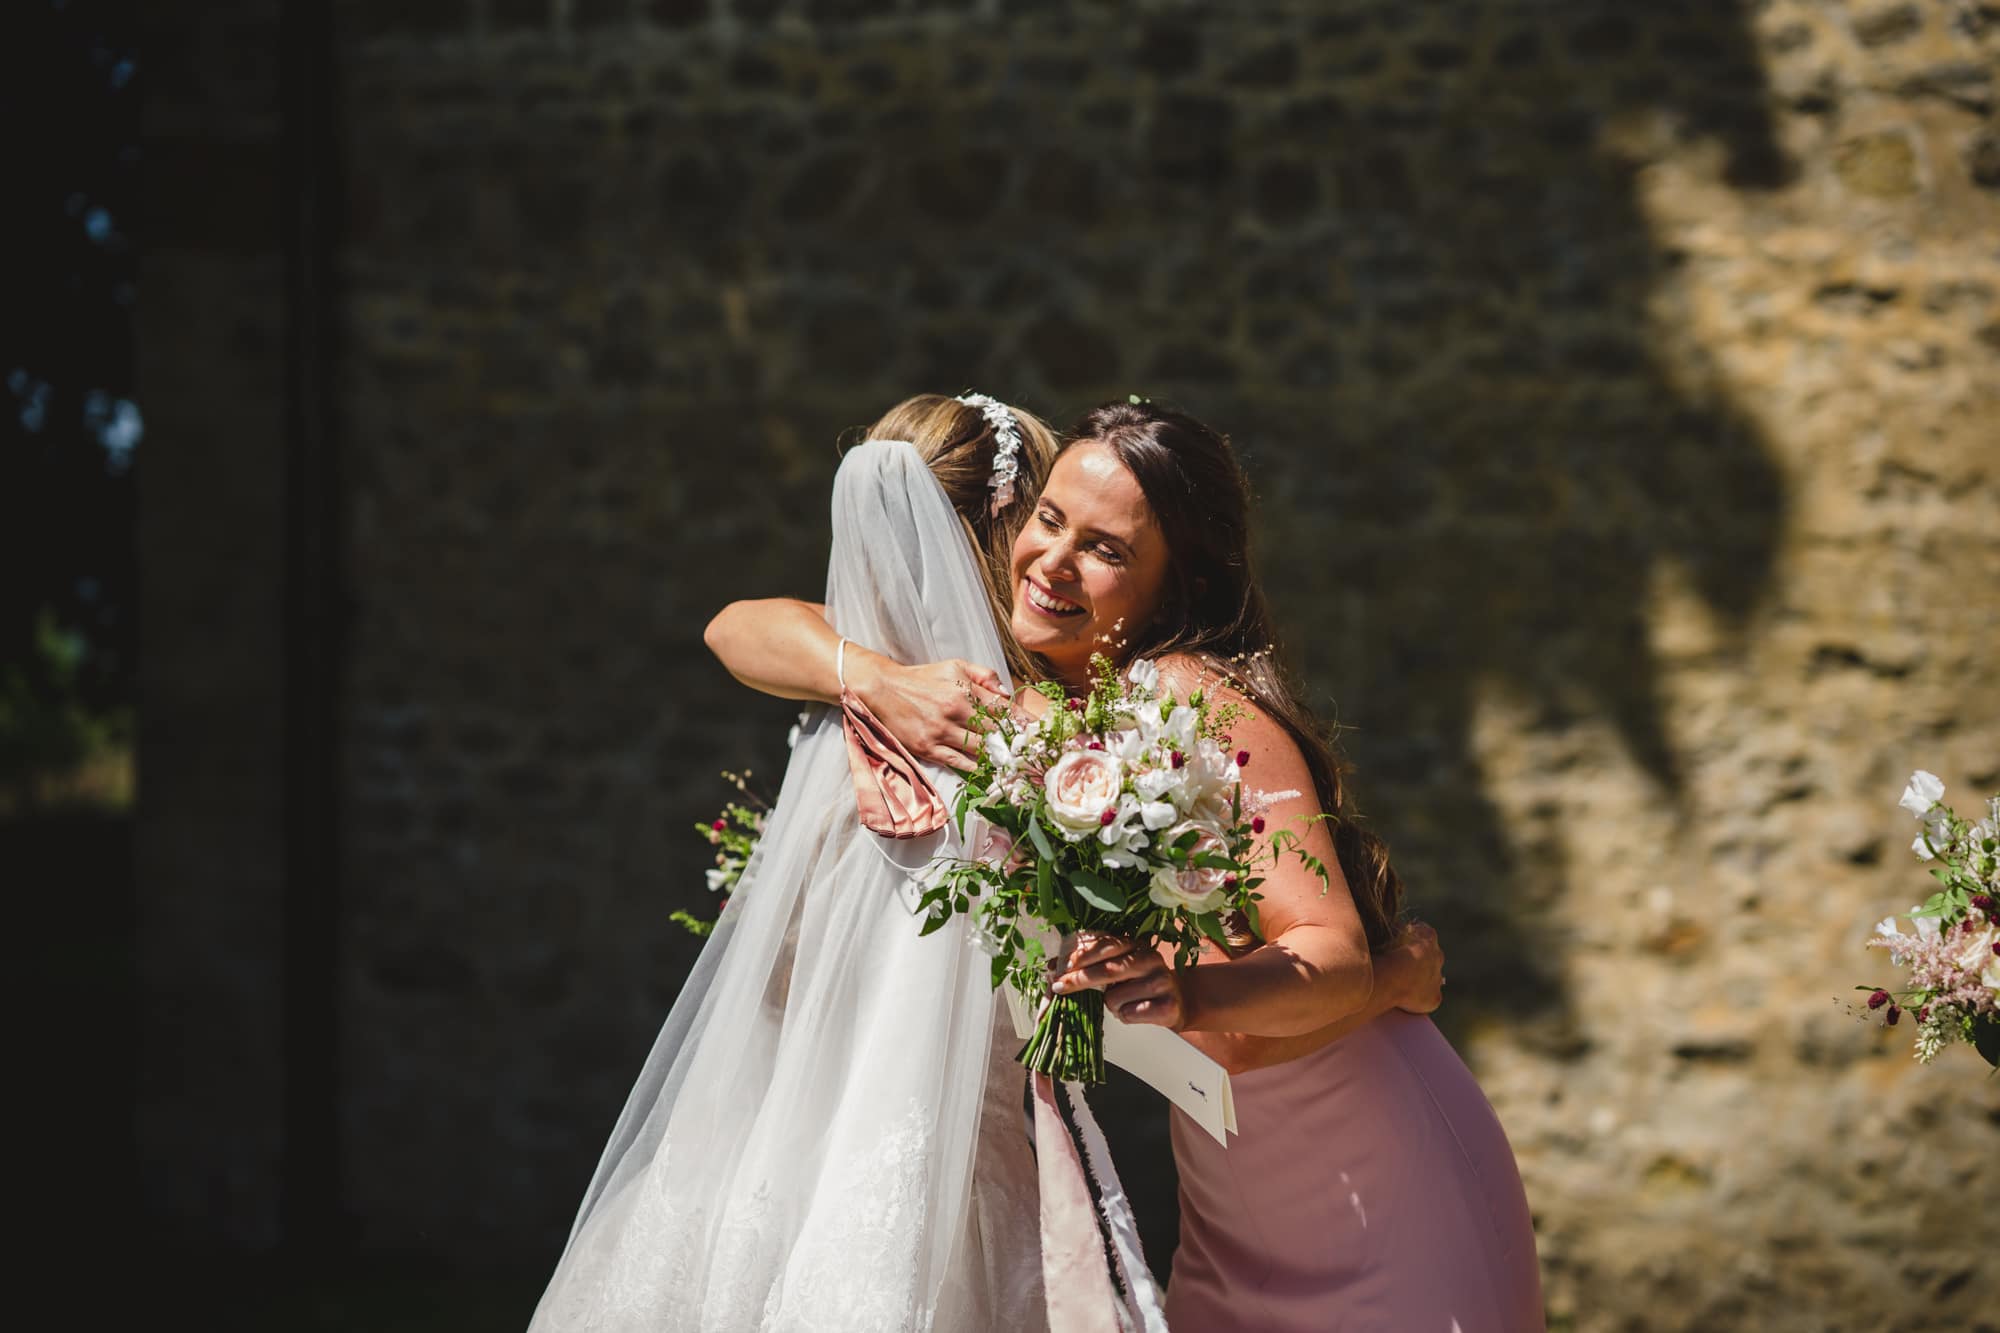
[1070,402,1402,949]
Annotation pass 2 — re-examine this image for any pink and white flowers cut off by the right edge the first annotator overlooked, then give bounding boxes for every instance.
[1856,769,2000,1069]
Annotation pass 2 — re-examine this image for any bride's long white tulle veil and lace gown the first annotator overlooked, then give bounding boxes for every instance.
[530,440,1046,1333]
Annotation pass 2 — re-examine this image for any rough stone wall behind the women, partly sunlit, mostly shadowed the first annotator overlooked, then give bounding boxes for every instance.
[148,0,2000,1329]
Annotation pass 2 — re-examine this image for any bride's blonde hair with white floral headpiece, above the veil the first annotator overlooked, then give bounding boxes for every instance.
[862,394,1062,685]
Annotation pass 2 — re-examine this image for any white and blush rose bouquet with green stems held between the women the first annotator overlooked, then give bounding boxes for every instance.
[918,654,1330,1083]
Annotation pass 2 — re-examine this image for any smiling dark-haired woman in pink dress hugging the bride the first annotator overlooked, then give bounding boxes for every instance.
[1012,404,1544,1333]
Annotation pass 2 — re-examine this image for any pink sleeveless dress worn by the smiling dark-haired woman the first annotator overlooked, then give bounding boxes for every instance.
[1166,1011,1544,1333]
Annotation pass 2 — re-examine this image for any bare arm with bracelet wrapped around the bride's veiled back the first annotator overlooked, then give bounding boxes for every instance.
[702,596,1006,771]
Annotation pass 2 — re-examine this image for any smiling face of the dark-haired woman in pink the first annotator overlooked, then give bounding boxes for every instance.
[1012,440,1168,685]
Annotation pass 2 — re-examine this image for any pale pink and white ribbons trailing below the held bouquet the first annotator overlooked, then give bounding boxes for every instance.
[1034,1073,1166,1333]
